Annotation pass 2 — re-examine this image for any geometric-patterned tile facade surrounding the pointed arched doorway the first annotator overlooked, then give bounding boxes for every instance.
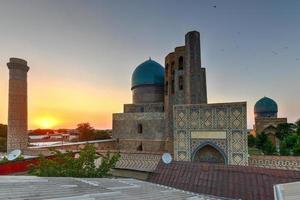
[174,103,248,165]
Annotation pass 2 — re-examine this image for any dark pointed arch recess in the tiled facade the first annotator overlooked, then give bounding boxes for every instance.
[193,144,225,164]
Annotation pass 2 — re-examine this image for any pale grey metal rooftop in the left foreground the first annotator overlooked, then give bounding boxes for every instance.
[0,176,229,200]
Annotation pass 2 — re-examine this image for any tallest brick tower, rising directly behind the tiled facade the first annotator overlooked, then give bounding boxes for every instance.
[184,31,207,104]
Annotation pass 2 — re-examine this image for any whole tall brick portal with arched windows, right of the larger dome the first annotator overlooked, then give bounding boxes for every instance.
[164,31,207,150]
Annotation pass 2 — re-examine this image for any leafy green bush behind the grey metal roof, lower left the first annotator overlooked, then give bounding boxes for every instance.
[29,145,120,177]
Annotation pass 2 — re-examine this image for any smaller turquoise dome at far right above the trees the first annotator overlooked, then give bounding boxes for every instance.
[254,97,278,114]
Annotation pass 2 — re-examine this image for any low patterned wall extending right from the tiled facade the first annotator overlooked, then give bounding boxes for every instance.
[249,156,300,171]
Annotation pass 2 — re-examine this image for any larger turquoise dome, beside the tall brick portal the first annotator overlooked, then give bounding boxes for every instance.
[131,59,165,89]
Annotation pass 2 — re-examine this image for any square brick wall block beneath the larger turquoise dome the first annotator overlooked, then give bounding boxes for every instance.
[113,112,165,152]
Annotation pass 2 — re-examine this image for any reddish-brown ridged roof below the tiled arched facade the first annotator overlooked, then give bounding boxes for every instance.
[150,161,300,200]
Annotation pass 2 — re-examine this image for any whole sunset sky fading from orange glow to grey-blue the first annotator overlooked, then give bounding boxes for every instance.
[0,0,300,129]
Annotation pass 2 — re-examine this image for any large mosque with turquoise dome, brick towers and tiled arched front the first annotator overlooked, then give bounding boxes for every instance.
[113,31,248,165]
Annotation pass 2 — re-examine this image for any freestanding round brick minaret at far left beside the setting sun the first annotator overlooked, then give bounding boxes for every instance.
[7,58,29,152]
